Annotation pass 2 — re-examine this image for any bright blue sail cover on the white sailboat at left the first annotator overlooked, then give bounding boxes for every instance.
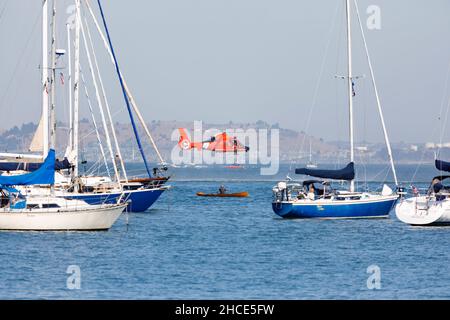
[0,149,55,186]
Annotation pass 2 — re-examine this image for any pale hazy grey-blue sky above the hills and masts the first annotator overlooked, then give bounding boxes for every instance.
[0,0,450,142]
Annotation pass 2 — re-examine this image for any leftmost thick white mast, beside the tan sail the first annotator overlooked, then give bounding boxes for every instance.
[41,0,48,159]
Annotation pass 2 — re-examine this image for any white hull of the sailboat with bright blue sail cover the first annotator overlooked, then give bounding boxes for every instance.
[0,204,126,231]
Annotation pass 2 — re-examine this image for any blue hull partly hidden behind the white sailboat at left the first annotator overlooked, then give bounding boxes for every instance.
[60,188,166,212]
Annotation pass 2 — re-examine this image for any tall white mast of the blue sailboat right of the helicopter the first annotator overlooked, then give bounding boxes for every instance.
[346,0,355,192]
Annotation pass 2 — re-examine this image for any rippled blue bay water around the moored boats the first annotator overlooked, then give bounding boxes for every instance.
[0,166,450,299]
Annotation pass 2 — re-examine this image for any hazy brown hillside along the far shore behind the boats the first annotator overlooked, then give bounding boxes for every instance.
[0,119,440,163]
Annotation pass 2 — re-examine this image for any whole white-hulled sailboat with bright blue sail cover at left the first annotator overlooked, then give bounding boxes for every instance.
[0,0,127,231]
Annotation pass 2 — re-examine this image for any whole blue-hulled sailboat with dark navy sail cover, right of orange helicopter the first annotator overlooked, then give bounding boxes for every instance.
[272,0,398,219]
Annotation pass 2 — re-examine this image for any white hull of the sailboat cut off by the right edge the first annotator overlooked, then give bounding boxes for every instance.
[395,196,450,226]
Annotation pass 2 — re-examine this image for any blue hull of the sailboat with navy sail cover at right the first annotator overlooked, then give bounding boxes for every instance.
[272,198,397,219]
